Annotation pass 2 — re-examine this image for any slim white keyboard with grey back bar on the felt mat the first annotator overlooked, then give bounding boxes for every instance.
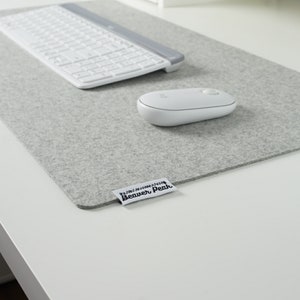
[0,4,183,89]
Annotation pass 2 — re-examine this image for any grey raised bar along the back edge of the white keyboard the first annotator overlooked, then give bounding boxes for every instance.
[60,3,184,65]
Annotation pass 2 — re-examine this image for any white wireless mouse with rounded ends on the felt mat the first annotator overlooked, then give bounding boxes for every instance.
[137,88,236,126]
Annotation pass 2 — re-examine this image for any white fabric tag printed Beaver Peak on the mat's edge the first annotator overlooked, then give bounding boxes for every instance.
[113,178,176,205]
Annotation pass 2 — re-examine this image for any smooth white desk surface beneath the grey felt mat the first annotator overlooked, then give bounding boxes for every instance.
[0,0,300,300]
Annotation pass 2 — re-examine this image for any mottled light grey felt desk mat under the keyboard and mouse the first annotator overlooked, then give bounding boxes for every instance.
[0,0,300,209]
